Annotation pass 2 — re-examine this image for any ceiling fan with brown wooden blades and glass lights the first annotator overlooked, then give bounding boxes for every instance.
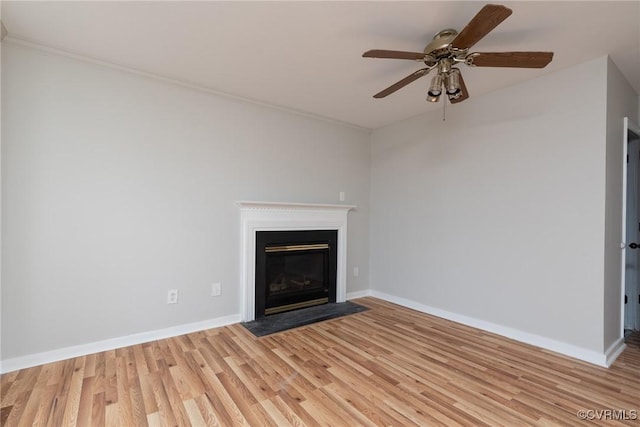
[362,4,553,104]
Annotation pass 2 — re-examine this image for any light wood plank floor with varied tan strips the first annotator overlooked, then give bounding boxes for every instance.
[0,298,640,426]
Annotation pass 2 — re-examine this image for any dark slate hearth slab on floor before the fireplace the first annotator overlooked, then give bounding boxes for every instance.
[242,301,368,337]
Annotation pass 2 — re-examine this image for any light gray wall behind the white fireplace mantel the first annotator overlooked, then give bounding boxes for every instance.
[2,44,370,359]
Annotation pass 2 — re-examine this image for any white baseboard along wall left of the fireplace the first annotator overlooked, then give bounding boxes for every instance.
[0,314,240,374]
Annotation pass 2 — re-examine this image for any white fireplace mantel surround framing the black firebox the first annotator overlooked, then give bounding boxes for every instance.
[236,201,356,322]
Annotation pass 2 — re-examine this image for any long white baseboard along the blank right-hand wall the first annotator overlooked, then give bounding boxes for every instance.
[371,290,625,368]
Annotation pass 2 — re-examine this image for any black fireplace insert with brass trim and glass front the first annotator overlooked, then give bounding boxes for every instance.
[255,230,338,319]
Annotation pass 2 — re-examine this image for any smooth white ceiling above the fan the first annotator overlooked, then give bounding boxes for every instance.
[1,0,640,128]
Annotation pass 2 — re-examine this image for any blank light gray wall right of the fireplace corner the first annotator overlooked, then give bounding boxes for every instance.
[370,58,619,354]
